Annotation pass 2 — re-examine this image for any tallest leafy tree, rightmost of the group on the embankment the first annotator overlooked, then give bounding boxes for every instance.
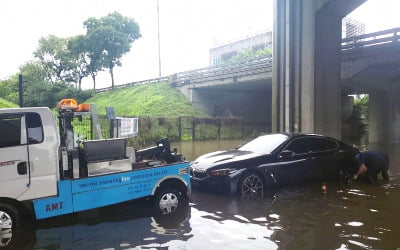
[84,12,141,88]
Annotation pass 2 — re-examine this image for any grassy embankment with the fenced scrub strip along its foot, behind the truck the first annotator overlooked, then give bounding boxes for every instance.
[82,82,243,148]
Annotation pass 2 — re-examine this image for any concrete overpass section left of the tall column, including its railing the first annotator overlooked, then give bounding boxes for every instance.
[169,56,272,131]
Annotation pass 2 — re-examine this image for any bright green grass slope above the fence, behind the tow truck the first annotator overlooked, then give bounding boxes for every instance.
[86,82,206,117]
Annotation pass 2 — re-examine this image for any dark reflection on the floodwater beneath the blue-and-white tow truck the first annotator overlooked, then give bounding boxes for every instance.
[4,201,192,250]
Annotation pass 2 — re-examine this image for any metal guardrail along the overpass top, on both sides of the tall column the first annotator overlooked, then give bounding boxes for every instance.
[96,27,400,93]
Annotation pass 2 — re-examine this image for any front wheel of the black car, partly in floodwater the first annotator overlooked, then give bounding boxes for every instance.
[238,172,264,199]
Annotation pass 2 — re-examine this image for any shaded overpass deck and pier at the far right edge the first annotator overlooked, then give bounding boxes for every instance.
[342,41,400,143]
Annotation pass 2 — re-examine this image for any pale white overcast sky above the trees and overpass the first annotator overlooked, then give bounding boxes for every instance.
[0,0,400,88]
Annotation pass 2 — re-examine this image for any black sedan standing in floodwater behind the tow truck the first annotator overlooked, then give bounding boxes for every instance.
[190,133,358,195]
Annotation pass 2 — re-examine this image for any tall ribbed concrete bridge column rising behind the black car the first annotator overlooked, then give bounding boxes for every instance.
[272,0,365,139]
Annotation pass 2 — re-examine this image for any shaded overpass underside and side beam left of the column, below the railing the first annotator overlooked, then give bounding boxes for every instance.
[179,74,272,133]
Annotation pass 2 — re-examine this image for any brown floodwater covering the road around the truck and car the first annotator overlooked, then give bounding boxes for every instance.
[5,141,400,250]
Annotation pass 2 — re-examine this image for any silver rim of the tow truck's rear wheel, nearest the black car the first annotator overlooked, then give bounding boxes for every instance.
[156,189,183,214]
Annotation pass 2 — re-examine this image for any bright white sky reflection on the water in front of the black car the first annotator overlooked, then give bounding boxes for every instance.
[188,192,277,249]
